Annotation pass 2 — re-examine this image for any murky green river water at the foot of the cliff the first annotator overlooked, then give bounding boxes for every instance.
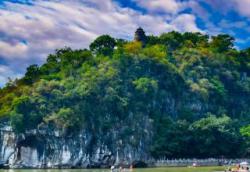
[0,167,225,172]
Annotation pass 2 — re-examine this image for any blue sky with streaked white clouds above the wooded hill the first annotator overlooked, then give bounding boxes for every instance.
[0,0,250,87]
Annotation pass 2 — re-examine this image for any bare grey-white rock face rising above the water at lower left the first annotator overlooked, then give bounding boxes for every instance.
[0,120,150,168]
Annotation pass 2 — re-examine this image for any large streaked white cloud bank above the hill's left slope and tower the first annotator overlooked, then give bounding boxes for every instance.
[0,0,199,86]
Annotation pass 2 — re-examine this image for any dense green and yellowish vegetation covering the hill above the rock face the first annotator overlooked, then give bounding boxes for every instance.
[0,28,250,158]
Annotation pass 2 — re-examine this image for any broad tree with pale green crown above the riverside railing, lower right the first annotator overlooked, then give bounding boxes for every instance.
[190,115,242,157]
